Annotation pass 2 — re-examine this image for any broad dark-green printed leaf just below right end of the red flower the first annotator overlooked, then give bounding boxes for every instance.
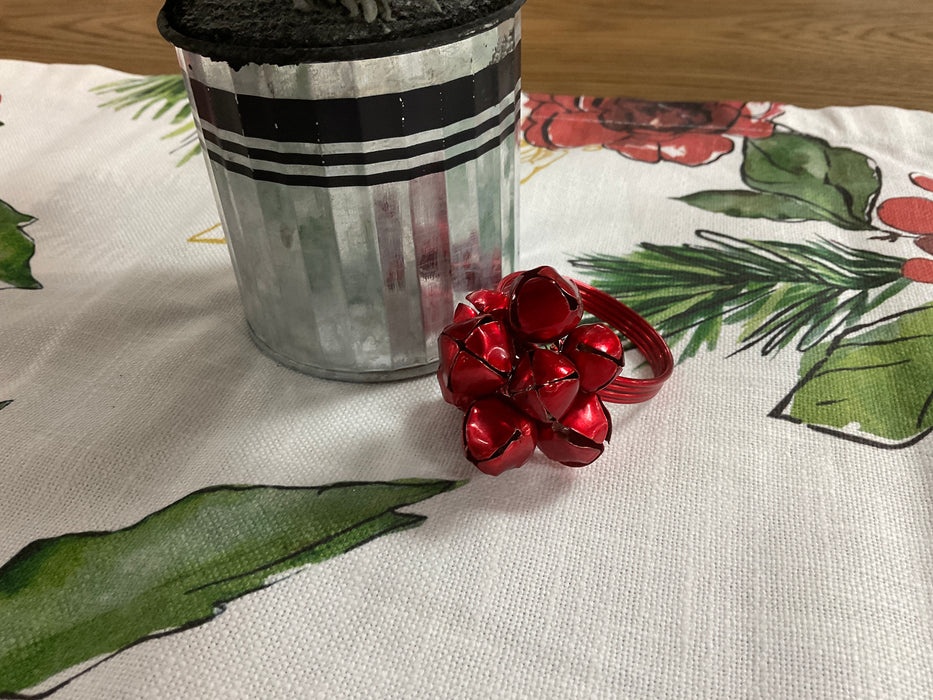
[742,133,881,231]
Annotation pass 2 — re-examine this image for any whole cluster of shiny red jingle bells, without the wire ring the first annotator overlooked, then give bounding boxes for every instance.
[437,267,623,476]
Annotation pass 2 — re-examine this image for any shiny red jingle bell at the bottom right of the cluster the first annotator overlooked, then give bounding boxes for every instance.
[538,393,612,467]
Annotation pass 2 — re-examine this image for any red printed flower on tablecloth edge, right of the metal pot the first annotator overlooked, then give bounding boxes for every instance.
[522,94,783,165]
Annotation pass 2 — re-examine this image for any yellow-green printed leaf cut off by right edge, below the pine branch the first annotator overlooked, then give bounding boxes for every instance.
[771,304,933,447]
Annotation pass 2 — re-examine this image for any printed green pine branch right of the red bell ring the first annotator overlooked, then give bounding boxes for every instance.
[571,231,909,361]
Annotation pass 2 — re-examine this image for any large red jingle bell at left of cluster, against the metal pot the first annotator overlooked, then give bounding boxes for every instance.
[437,314,515,410]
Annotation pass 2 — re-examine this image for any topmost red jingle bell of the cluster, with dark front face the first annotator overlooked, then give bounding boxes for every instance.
[502,266,583,343]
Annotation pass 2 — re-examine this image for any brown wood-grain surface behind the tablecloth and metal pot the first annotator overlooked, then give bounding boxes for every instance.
[0,0,933,111]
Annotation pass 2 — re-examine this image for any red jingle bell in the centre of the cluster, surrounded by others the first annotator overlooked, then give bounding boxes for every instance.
[509,348,580,421]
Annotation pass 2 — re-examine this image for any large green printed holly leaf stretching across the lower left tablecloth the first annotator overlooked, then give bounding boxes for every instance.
[0,479,465,695]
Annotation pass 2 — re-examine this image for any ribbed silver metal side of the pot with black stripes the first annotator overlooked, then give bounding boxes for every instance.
[160,2,521,382]
